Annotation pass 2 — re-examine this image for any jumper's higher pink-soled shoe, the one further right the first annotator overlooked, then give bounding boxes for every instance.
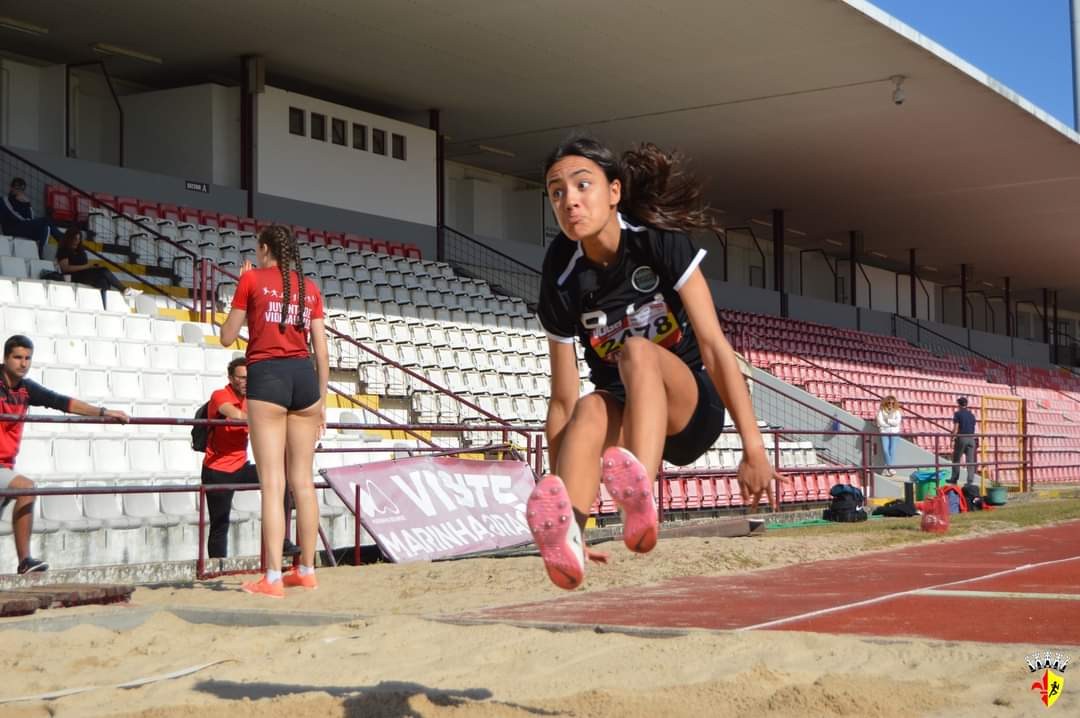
[600,446,659,554]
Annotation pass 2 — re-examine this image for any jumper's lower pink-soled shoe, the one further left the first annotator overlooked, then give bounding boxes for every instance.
[525,475,585,591]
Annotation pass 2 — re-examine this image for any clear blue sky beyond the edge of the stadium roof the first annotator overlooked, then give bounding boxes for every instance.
[870,0,1074,127]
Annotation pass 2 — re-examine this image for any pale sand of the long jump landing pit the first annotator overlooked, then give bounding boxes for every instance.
[0,516,1068,718]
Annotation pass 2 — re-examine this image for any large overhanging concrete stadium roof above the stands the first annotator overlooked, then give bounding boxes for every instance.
[4,0,1080,308]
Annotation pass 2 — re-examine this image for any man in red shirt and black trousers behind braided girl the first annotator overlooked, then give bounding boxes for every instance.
[202,356,296,558]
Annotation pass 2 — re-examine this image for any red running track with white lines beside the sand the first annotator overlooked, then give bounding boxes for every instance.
[465,521,1080,647]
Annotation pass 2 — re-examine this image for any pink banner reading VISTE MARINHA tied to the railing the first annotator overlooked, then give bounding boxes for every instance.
[320,457,536,564]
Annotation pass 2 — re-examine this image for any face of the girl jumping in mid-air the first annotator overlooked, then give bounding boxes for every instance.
[545,157,622,242]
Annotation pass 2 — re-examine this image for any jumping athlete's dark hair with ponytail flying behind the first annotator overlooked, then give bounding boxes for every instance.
[544,135,720,231]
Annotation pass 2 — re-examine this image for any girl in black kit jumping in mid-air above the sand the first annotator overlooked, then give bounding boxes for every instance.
[526,137,780,588]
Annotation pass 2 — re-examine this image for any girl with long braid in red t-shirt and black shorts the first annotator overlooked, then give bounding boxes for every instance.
[221,225,329,598]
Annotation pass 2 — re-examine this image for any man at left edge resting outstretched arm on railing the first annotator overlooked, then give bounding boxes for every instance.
[0,335,127,573]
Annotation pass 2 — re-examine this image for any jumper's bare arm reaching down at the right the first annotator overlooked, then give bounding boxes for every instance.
[678,269,779,506]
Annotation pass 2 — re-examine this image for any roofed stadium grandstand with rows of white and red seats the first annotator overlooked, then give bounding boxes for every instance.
[0,0,1080,572]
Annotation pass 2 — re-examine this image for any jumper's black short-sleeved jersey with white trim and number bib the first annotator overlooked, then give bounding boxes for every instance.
[538,215,705,389]
